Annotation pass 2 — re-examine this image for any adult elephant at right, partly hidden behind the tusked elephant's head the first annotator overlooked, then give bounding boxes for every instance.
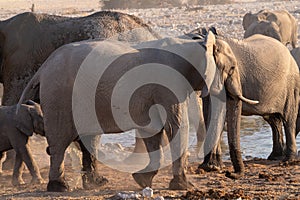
[192,29,300,178]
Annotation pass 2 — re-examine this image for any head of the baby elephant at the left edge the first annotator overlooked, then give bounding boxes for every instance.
[15,101,45,136]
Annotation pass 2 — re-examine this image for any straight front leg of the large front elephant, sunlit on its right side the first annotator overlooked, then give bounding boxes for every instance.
[165,103,193,190]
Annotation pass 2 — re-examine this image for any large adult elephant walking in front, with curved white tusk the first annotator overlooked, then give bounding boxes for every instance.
[19,34,257,191]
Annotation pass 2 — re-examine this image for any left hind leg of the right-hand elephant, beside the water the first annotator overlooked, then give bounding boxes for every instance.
[264,114,284,160]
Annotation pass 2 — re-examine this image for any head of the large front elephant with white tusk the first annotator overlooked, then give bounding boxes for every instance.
[206,34,258,104]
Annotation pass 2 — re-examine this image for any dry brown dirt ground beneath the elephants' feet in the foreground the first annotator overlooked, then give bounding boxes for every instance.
[0,159,300,200]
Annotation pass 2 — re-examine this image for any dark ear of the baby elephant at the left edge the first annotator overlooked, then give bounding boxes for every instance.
[14,105,33,136]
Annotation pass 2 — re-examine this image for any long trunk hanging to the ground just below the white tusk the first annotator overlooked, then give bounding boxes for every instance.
[226,97,245,179]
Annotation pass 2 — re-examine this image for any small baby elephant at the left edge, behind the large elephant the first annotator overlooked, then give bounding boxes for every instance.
[0,101,45,185]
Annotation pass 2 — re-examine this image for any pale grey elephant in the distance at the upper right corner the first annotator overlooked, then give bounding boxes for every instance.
[243,10,298,48]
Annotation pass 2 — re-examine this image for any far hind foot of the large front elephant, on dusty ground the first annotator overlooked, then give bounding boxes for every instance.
[82,172,108,190]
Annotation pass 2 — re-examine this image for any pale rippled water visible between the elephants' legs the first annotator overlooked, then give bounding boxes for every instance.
[101,116,300,159]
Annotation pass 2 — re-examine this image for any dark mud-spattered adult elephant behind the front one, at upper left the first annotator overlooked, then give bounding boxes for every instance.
[0,11,158,169]
